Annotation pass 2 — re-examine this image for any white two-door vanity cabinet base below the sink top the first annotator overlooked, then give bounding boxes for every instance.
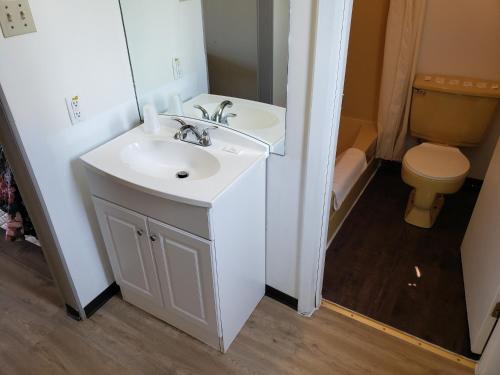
[88,156,265,352]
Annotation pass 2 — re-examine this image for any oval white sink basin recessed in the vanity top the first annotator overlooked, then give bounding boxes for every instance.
[120,139,220,180]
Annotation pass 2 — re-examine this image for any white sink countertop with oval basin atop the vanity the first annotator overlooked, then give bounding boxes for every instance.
[80,116,269,207]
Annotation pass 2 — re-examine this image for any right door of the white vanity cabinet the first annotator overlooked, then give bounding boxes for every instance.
[148,219,218,346]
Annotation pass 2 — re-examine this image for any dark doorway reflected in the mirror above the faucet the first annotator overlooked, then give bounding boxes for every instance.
[203,0,290,107]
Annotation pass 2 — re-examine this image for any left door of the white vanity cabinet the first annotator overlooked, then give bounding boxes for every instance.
[93,197,162,305]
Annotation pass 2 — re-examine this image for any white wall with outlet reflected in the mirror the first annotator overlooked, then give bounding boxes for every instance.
[121,0,208,112]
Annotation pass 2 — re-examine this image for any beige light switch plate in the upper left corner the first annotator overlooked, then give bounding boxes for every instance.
[0,0,36,38]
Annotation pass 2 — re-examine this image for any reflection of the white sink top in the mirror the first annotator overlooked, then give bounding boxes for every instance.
[183,94,286,154]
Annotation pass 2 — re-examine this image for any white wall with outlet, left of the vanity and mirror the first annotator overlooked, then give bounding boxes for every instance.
[0,0,139,306]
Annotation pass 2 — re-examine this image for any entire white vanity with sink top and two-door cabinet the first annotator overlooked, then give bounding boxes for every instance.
[80,116,269,352]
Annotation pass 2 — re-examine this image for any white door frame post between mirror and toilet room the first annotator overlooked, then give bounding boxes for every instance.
[298,0,353,316]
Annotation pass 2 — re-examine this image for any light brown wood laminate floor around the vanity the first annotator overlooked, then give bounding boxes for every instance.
[0,235,473,375]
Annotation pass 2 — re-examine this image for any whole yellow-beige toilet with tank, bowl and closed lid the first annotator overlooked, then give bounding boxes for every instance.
[401,75,500,228]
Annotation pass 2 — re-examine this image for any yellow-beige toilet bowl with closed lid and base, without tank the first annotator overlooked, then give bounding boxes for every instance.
[401,143,470,228]
